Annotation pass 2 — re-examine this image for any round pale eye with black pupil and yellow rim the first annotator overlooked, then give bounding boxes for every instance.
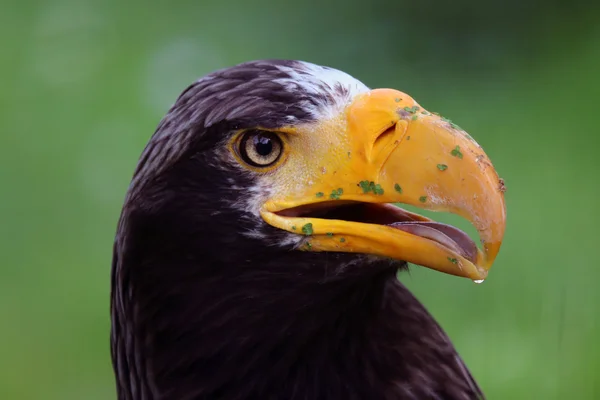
[239,130,283,167]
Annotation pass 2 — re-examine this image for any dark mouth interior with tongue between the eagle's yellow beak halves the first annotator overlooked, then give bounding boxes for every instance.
[277,200,478,263]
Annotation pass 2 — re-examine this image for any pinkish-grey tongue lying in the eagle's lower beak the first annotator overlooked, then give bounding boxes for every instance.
[389,221,477,262]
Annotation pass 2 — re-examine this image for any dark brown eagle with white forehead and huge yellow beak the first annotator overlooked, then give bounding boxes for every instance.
[111,60,506,400]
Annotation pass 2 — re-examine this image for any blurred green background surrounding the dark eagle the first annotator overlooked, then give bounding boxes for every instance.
[0,0,600,400]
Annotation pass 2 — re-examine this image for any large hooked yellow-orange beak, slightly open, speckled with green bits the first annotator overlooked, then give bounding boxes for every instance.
[261,89,506,280]
